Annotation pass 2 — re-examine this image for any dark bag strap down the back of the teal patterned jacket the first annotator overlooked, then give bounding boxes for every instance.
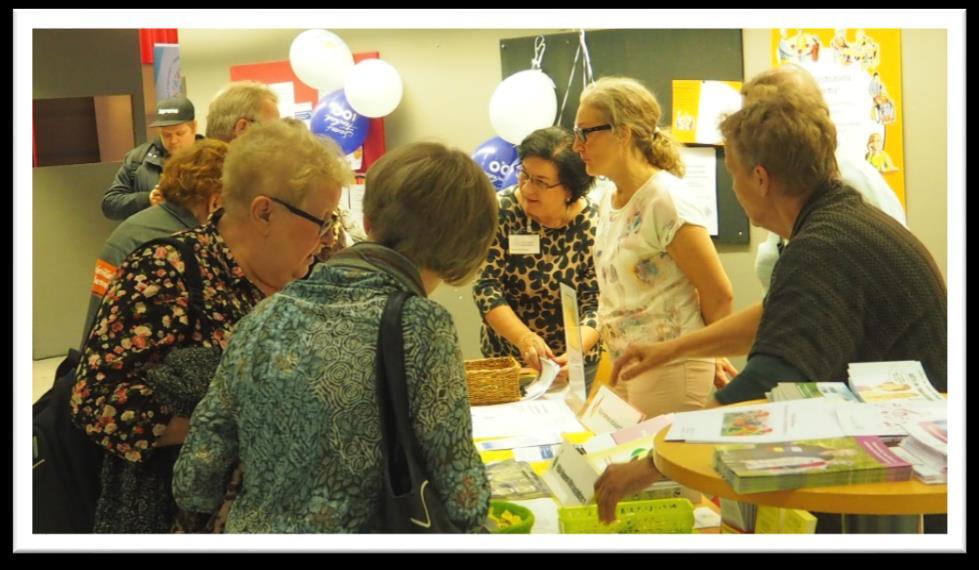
[376,291,427,495]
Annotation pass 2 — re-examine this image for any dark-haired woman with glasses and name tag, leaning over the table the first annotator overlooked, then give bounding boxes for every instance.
[473,127,600,387]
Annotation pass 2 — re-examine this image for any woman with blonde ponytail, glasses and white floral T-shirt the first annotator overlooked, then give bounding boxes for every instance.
[574,77,735,417]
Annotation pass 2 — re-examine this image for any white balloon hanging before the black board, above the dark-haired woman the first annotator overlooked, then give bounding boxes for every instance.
[490,69,557,144]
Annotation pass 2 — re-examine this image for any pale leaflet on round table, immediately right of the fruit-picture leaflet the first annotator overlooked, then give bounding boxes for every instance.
[836,400,947,437]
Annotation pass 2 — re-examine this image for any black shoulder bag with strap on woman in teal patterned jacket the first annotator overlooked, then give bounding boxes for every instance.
[375,291,463,534]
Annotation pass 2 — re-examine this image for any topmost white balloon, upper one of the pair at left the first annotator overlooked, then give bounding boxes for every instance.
[289,30,354,93]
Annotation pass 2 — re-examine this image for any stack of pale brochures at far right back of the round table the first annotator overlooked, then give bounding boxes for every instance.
[847,360,943,402]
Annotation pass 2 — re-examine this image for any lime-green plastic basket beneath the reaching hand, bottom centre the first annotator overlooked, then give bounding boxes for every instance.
[558,498,694,534]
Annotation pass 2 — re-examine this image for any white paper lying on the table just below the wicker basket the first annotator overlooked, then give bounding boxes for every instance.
[471,399,585,439]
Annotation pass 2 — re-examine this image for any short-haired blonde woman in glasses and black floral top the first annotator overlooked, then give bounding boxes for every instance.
[71,117,352,533]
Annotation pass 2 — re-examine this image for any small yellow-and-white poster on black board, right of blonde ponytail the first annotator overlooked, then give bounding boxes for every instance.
[671,79,741,145]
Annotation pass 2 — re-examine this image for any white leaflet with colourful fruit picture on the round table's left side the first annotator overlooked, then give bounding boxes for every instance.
[666,398,844,443]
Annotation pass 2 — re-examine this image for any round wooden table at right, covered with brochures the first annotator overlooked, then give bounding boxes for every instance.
[654,406,948,532]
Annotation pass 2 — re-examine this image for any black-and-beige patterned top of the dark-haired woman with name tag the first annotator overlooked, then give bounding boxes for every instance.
[473,187,601,365]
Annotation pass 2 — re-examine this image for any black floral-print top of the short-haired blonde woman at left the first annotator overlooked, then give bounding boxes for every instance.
[71,213,264,462]
